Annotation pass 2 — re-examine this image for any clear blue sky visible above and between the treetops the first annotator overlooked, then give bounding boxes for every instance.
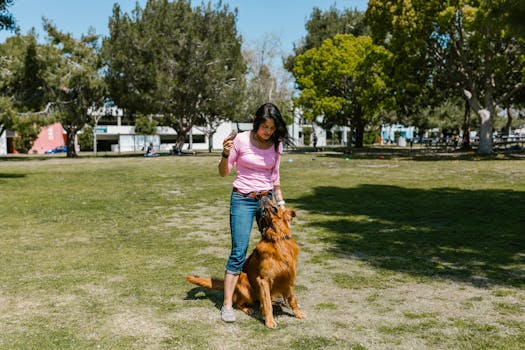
[0,0,368,53]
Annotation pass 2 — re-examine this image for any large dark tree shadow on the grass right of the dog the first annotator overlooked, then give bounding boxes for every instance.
[289,185,525,287]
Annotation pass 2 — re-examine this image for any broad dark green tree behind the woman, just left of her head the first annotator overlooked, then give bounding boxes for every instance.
[104,0,244,152]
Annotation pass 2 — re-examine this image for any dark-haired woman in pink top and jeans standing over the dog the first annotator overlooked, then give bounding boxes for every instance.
[219,103,291,322]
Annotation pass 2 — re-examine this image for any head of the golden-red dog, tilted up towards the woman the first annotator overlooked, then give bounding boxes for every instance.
[256,197,295,241]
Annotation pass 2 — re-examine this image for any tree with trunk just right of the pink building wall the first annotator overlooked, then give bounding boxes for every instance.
[44,19,106,158]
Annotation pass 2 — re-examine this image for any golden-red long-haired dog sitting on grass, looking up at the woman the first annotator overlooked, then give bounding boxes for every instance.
[186,197,306,328]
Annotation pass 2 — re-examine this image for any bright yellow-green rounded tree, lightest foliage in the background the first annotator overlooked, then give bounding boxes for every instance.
[293,34,390,147]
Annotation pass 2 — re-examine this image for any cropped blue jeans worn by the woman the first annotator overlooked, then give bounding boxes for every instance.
[226,192,272,275]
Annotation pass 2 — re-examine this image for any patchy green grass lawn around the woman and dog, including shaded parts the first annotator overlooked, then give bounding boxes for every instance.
[0,154,525,349]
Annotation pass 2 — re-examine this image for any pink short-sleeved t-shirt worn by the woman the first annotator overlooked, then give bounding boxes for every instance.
[228,131,283,193]
